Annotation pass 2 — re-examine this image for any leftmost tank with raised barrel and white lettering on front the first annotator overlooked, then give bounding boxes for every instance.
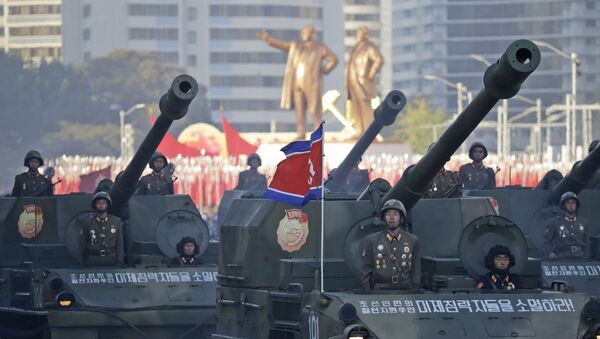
[0,75,216,338]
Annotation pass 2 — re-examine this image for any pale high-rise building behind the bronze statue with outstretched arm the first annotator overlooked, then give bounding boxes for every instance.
[63,0,344,131]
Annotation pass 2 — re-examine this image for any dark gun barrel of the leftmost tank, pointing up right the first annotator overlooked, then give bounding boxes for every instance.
[109,74,198,216]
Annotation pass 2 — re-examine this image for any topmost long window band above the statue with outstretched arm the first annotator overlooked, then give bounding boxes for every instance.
[210,5,323,19]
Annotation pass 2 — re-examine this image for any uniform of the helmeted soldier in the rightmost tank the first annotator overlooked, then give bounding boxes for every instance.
[543,214,590,259]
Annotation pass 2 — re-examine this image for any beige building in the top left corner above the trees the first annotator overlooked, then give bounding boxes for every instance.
[0,0,62,64]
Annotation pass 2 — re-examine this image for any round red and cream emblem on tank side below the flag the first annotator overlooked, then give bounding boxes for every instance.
[277,209,308,253]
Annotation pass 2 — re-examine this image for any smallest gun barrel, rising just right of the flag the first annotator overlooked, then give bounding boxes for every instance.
[325,90,406,192]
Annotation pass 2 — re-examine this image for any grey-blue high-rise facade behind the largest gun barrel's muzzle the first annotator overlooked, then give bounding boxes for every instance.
[388,0,600,149]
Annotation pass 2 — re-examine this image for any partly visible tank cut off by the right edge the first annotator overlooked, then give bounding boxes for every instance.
[466,143,600,296]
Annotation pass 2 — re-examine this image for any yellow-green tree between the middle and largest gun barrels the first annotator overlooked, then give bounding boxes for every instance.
[391,98,445,154]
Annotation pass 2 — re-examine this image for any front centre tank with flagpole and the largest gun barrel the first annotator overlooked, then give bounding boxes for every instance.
[212,40,599,339]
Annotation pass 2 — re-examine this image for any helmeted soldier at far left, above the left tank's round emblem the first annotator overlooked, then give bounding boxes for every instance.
[11,150,54,197]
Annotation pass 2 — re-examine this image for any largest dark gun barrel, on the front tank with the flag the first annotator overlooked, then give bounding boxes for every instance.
[382,40,541,210]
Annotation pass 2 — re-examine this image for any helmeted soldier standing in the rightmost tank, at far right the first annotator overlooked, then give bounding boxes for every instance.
[543,192,590,259]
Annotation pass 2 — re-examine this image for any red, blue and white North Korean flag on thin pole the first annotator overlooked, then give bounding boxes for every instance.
[263,124,323,207]
